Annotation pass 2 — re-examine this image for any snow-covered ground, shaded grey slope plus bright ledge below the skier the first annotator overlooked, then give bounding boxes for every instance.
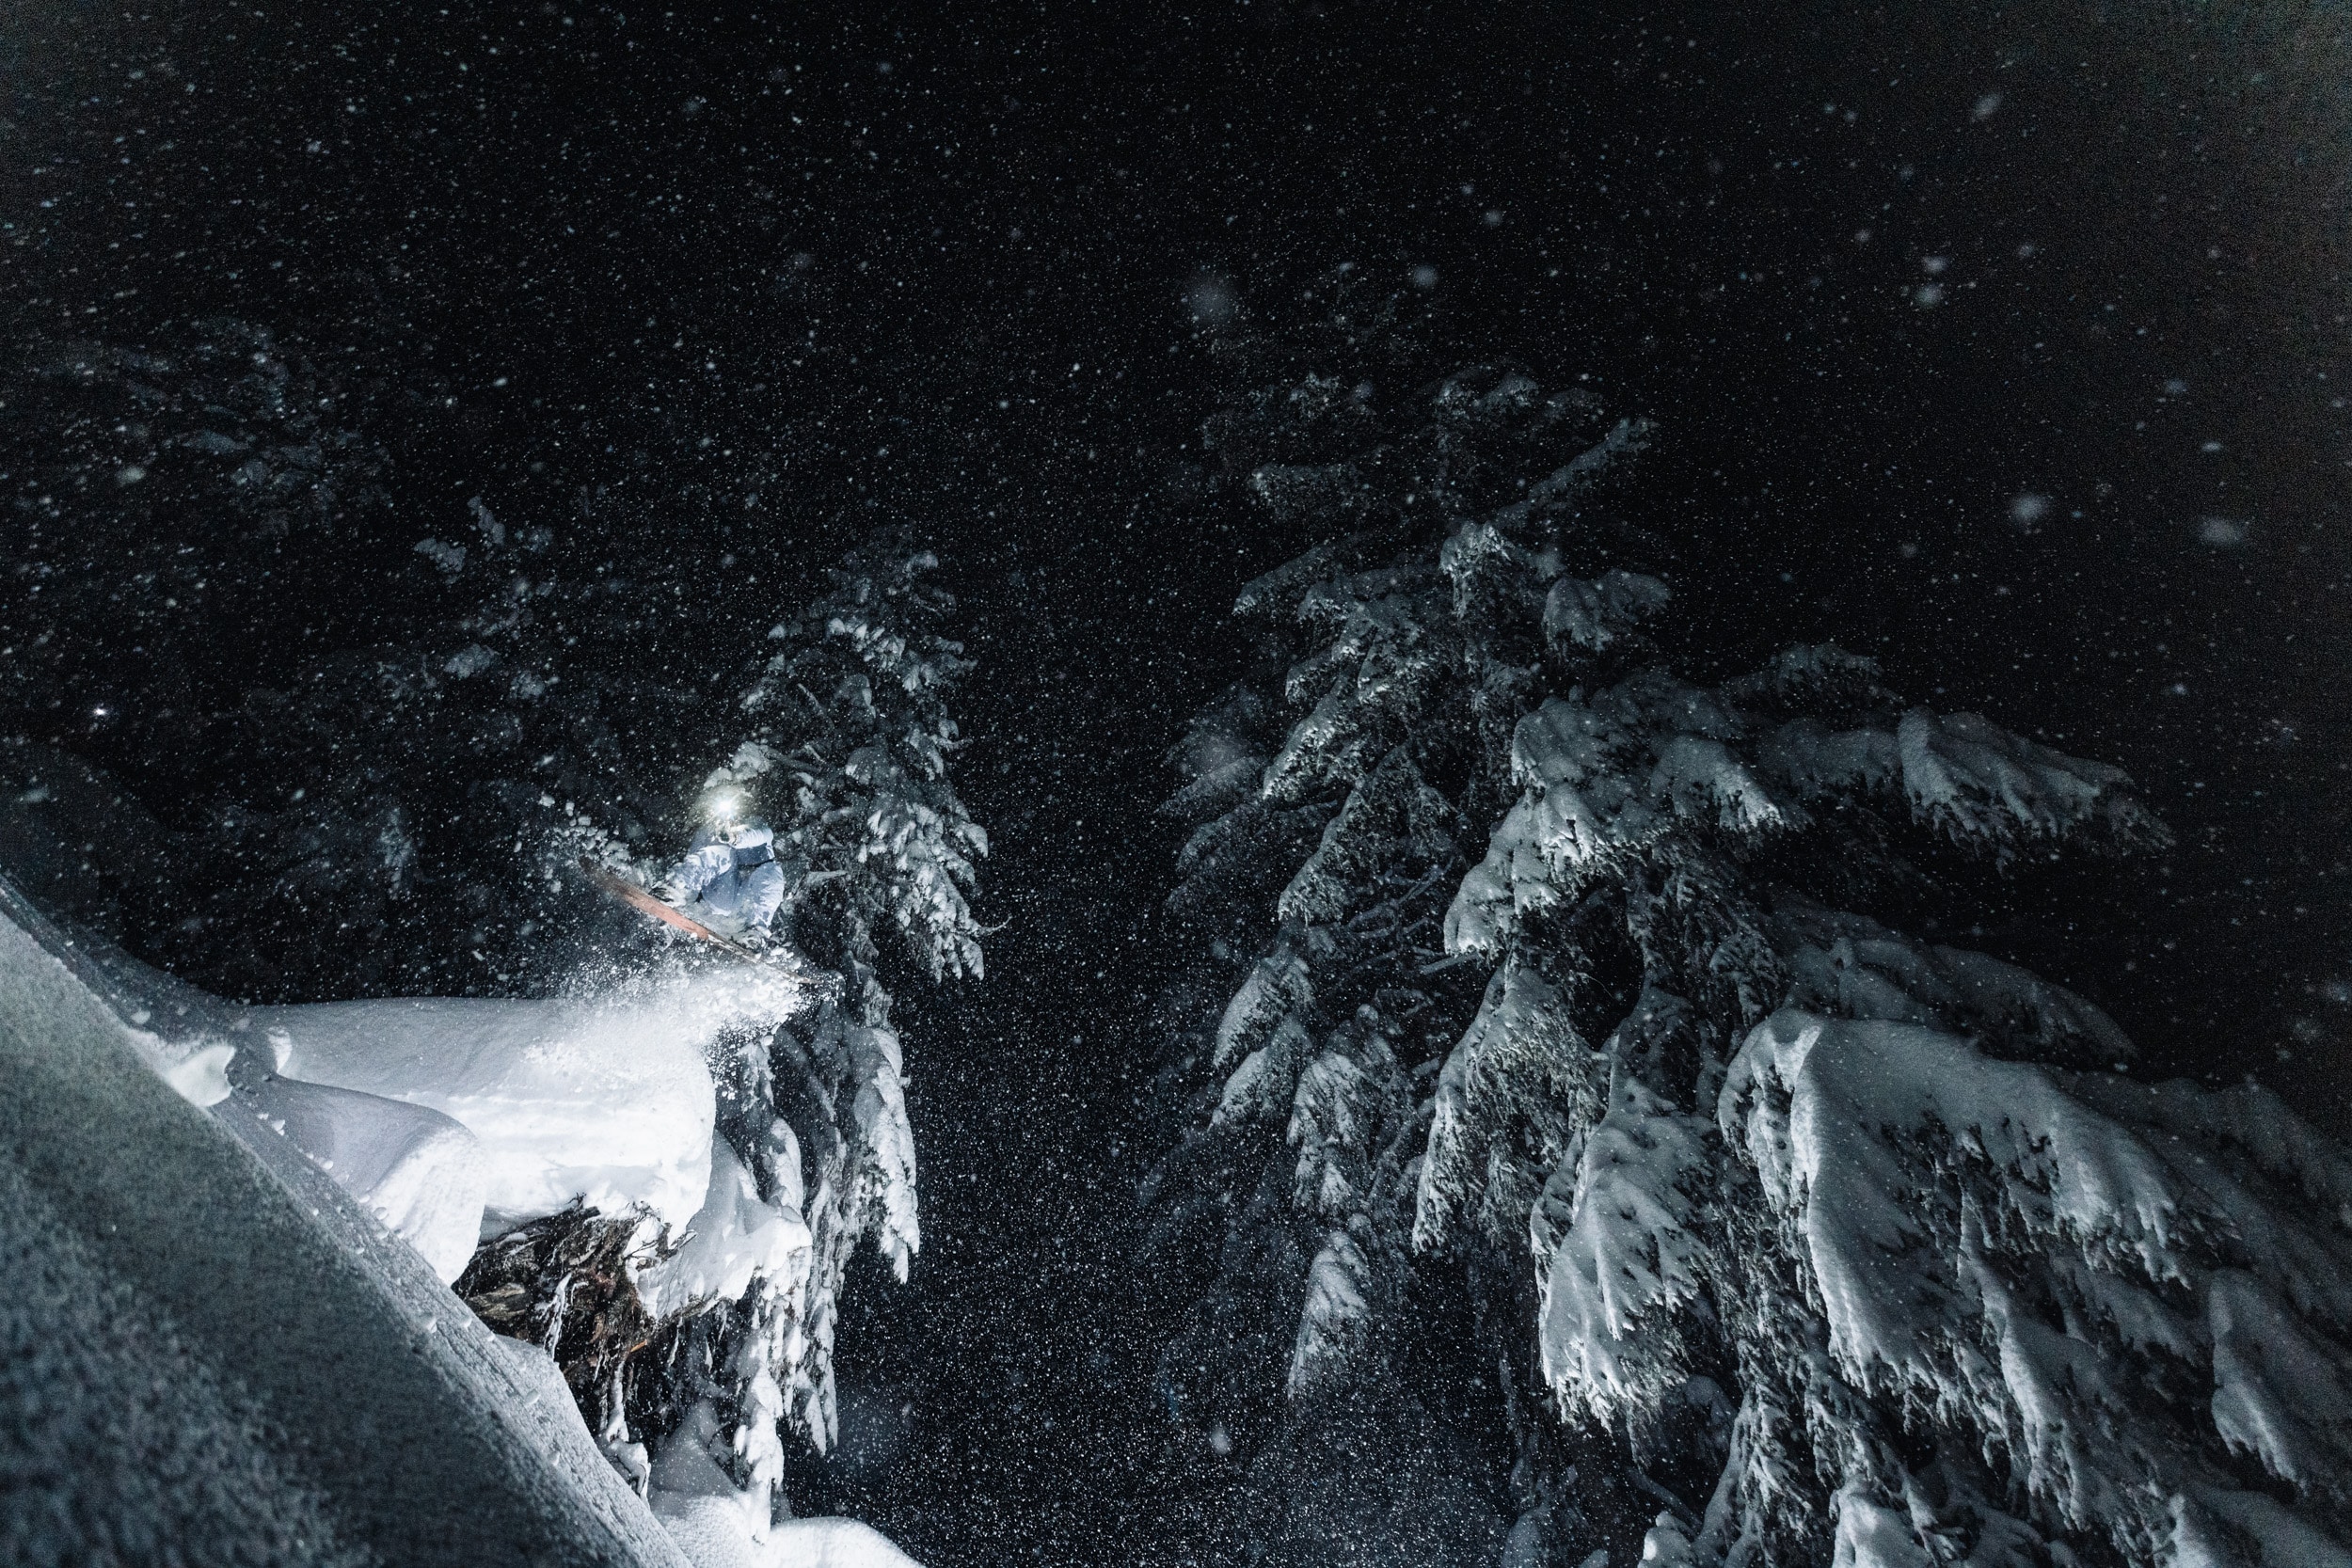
[0,884,911,1568]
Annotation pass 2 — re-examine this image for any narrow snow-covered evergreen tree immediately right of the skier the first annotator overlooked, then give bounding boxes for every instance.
[673,531,988,1486]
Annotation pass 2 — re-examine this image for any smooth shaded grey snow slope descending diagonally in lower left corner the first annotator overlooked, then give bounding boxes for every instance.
[0,884,687,1568]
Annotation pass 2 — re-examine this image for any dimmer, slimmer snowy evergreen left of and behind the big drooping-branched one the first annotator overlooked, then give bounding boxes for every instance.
[1151,324,1645,1561]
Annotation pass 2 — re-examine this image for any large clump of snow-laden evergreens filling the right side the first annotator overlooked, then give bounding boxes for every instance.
[1148,322,2352,1568]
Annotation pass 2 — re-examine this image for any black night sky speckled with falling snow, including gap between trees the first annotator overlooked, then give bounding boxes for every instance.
[0,0,2352,1566]
